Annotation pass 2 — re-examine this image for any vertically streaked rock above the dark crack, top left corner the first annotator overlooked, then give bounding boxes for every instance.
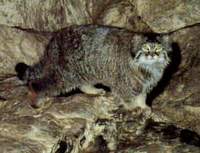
[0,0,91,31]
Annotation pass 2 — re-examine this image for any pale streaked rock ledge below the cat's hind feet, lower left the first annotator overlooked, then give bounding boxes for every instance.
[0,93,119,153]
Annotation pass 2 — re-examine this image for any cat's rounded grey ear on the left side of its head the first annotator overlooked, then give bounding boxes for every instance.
[131,34,147,56]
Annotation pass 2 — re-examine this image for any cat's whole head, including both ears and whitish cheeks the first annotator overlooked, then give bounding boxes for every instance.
[130,35,172,68]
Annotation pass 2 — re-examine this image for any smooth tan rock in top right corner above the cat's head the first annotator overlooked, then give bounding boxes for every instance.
[136,0,200,33]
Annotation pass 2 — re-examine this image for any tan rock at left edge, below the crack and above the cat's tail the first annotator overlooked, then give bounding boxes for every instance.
[0,26,49,74]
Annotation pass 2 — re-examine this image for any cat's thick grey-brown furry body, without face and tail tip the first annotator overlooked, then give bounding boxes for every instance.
[19,25,170,107]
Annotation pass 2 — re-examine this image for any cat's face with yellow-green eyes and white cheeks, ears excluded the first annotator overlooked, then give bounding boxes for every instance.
[134,42,169,66]
